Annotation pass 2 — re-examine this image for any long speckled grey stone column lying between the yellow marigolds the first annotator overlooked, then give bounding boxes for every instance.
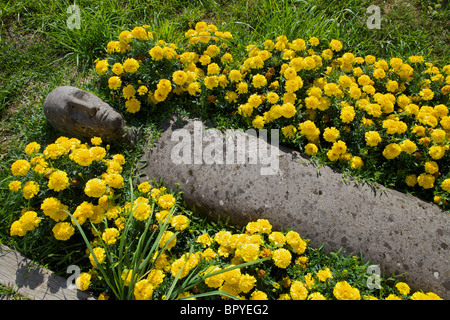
[141,120,450,299]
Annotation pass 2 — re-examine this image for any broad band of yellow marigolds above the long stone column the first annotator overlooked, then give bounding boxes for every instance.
[96,22,450,206]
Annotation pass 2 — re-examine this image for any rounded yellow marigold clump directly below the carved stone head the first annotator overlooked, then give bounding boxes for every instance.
[8,136,125,243]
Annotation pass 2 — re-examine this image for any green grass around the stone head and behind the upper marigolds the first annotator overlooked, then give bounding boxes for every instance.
[0,0,450,298]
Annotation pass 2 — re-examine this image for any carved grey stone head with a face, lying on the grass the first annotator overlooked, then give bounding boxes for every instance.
[43,86,129,142]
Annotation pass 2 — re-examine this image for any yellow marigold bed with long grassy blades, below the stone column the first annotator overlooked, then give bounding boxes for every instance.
[2,137,440,300]
